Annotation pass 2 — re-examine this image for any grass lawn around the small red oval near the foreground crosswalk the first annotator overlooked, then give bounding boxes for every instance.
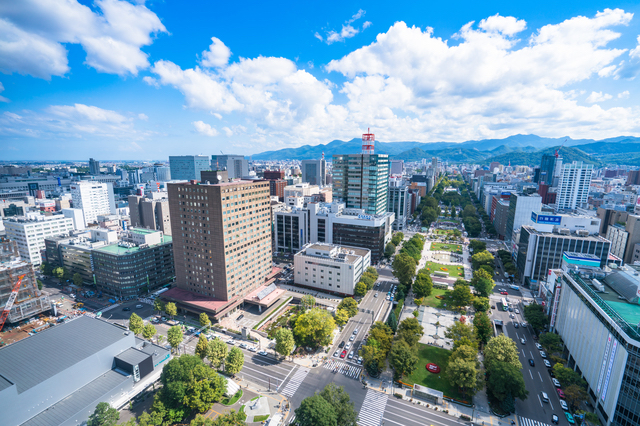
[402,343,471,401]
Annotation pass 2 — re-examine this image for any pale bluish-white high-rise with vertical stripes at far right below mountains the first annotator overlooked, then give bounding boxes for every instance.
[556,161,593,211]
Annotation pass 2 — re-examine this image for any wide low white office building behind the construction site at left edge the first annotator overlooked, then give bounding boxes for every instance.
[4,214,73,265]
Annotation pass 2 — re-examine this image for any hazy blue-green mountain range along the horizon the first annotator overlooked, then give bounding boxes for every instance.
[252,135,640,166]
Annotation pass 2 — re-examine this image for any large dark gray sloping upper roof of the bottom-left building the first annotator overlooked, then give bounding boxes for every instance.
[0,315,127,394]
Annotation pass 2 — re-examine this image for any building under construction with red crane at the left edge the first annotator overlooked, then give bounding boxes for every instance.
[0,241,52,346]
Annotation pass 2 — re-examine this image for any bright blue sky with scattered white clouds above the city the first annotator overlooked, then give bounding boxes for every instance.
[0,0,640,161]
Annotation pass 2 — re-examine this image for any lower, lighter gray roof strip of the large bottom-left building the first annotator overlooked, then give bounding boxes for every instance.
[21,370,129,426]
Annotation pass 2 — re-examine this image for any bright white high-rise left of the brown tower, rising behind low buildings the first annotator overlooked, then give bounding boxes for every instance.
[70,181,116,226]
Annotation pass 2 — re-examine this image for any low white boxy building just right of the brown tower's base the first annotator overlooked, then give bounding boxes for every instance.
[293,243,371,296]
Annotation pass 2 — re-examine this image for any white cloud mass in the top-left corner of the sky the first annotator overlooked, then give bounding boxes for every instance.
[0,0,166,80]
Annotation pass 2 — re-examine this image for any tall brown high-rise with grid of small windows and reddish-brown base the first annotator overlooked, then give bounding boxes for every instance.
[163,180,272,317]
